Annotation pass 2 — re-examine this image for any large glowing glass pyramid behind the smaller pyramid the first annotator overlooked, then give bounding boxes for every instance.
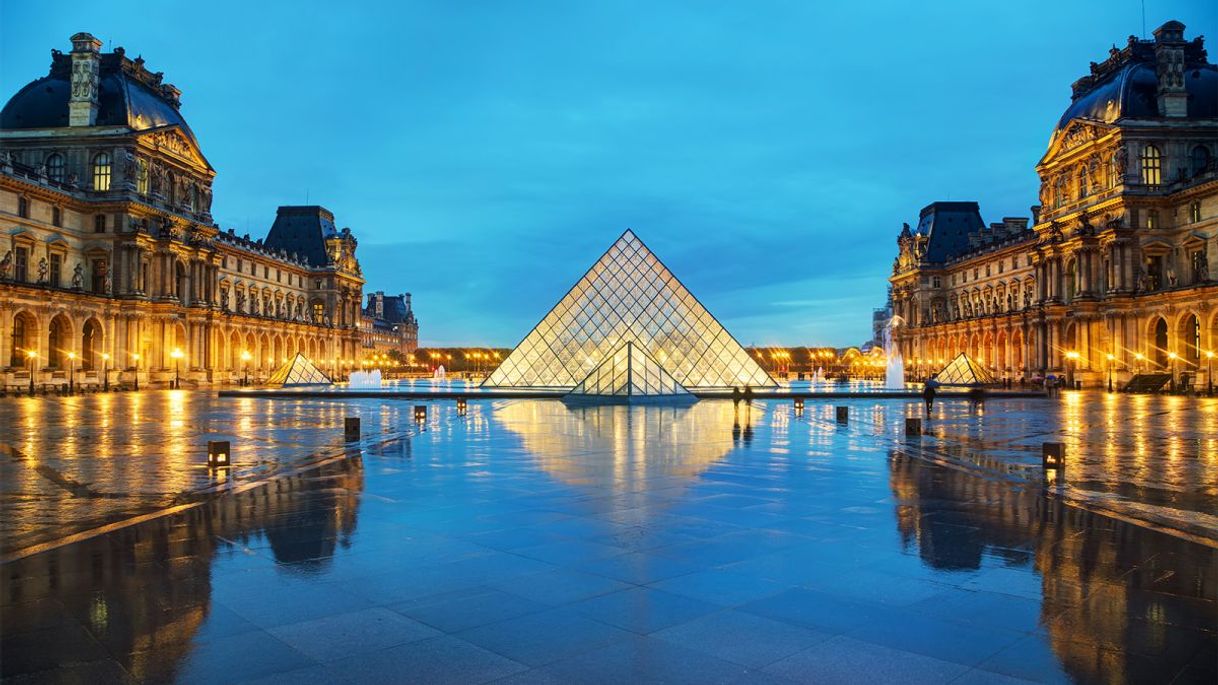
[482,230,777,390]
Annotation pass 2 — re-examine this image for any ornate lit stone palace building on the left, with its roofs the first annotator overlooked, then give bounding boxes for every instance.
[0,33,364,386]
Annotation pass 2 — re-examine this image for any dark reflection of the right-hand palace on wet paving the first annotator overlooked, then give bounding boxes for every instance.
[889,452,1218,683]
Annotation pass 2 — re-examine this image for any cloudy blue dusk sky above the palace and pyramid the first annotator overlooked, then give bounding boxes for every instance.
[0,0,1218,345]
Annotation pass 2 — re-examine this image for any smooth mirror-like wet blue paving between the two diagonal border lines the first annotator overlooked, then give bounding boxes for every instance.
[0,392,1218,684]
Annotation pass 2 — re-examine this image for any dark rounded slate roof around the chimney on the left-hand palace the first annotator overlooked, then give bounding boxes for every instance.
[0,51,199,146]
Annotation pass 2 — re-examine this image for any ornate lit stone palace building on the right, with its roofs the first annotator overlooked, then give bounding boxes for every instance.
[889,22,1218,384]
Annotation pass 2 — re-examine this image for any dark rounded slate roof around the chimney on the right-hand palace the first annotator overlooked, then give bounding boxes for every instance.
[1057,26,1218,130]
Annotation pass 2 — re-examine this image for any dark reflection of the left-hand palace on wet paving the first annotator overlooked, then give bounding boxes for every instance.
[0,457,364,681]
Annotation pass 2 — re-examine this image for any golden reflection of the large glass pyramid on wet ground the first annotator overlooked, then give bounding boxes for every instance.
[495,401,740,491]
